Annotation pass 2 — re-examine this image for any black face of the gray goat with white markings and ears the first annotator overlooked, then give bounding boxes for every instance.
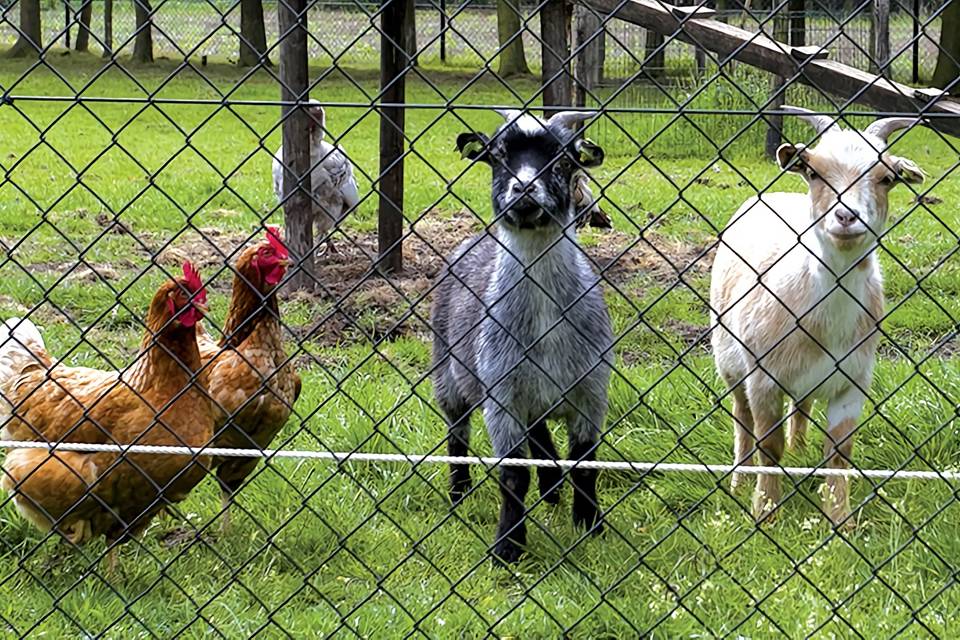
[457,114,603,229]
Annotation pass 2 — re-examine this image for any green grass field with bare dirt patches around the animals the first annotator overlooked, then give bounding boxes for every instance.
[0,56,960,638]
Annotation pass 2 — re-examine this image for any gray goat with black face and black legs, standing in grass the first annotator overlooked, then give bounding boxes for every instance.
[432,110,613,562]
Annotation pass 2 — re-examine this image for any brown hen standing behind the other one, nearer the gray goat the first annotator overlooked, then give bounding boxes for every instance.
[199,227,300,530]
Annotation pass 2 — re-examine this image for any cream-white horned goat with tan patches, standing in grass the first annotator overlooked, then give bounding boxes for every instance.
[710,107,923,524]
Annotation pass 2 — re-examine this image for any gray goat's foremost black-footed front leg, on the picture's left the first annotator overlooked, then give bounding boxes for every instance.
[492,401,530,564]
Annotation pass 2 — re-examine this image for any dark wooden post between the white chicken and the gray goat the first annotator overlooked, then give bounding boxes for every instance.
[376,0,410,274]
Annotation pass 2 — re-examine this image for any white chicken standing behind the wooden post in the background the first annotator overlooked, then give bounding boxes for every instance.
[273,100,360,250]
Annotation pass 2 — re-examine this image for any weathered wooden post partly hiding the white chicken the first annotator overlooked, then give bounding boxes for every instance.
[277,0,316,291]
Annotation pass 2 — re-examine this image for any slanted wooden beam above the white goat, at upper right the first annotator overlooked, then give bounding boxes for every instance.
[577,0,960,136]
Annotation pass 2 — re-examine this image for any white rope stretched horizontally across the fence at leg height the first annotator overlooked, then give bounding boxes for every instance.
[0,440,960,480]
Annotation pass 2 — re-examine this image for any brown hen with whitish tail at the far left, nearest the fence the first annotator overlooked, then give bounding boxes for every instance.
[0,263,214,544]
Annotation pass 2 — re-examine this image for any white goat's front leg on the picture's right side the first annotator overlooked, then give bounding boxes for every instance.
[823,387,866,526]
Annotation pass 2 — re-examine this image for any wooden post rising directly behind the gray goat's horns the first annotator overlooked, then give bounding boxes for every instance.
[540,0,573,110]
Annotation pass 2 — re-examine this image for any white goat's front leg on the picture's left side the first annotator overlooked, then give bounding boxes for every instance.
[750,389,784,522]
